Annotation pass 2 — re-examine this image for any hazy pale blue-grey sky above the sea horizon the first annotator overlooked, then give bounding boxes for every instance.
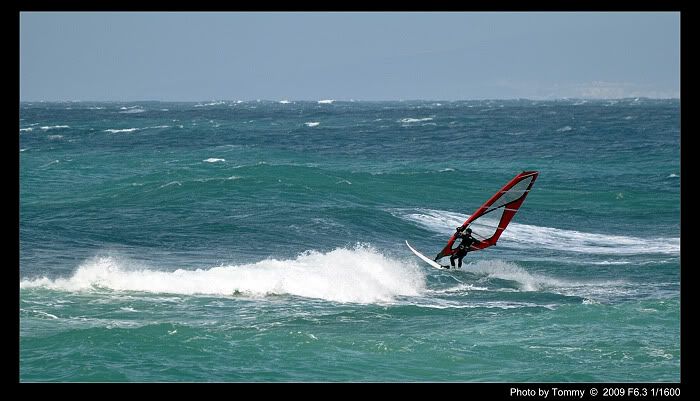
[19,12,680,101]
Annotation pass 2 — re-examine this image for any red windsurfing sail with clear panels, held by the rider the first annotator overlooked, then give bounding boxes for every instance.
[435,171,539,260]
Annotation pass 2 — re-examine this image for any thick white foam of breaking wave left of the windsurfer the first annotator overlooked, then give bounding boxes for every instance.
[20,245,425,303]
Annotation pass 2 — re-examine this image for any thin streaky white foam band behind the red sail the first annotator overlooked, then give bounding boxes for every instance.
[400,209,681,255]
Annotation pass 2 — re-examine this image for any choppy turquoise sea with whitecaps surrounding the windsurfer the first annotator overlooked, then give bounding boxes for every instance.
[19,99,681,382]
